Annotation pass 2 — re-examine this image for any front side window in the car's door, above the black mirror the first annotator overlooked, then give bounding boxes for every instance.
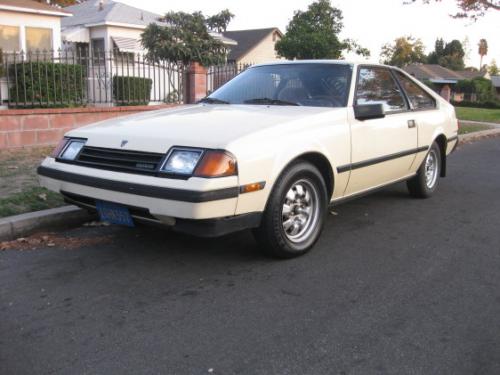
[356,67,408,113]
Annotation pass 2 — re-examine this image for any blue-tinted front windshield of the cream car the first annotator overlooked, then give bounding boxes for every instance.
[202,63,352,107]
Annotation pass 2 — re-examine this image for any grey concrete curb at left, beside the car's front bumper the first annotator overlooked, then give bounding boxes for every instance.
[0,206,94,241]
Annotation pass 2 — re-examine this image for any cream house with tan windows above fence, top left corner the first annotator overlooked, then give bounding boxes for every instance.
[0,0,71,53]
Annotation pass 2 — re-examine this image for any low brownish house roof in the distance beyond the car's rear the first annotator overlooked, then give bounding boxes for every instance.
[403,64,485,83]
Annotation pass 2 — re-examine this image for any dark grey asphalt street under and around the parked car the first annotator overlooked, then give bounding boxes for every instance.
[0,138,500,375]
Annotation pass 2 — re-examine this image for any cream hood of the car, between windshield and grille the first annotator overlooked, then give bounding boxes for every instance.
[67,104,345,152]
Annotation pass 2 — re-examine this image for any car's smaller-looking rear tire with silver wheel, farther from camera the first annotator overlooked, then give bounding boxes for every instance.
[406,142,441,198]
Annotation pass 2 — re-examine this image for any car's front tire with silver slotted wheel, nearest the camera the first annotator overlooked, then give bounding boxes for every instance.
[254,161,328,258]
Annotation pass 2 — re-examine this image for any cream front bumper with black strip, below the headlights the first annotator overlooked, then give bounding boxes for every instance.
[38,158,239,224]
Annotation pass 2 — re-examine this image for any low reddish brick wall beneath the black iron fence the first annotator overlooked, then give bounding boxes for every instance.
[0,105,180,150]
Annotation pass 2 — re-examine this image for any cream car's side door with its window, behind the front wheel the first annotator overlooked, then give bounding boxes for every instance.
[345,65,418,195]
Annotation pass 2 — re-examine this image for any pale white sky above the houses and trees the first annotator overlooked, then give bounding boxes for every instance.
[118,0,500,67]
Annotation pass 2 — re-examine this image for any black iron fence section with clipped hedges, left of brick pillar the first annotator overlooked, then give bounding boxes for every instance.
[0,49,186,108]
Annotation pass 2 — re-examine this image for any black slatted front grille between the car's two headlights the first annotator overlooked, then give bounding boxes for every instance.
[75,146,165,175]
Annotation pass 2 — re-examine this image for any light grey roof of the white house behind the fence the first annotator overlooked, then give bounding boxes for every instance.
[61,0,166,28]
